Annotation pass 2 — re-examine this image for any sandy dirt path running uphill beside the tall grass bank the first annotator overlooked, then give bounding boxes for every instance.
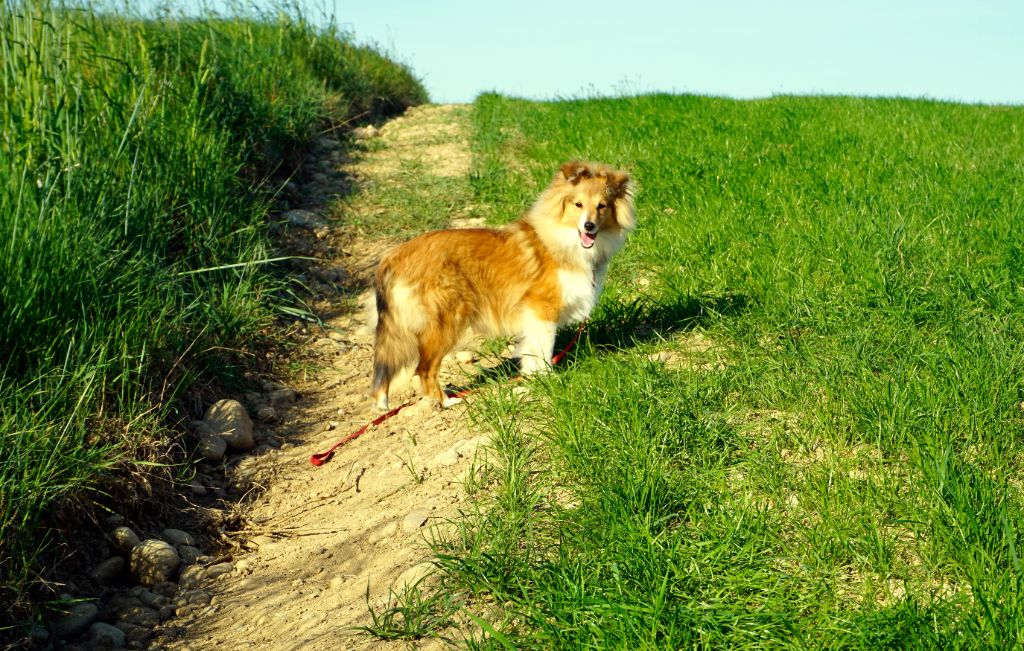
[161,105,484,650]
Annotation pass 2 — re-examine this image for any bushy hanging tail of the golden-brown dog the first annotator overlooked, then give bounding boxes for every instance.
[368,263,423,409]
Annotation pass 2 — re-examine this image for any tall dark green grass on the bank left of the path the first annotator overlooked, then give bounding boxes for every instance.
[0,2,426,628]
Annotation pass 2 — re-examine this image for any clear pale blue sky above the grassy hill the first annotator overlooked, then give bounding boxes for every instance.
[151,0,1024,103]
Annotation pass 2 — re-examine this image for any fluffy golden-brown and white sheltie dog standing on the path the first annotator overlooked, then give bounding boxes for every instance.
[371,161,635,409]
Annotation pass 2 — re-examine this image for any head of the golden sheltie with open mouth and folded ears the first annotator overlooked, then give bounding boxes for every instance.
[552,161,635,249]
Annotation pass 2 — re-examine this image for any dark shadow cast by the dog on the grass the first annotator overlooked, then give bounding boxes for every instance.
[446,294,748,395]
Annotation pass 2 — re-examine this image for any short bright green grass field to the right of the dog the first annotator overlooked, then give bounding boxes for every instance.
[377,95,1024,649]
